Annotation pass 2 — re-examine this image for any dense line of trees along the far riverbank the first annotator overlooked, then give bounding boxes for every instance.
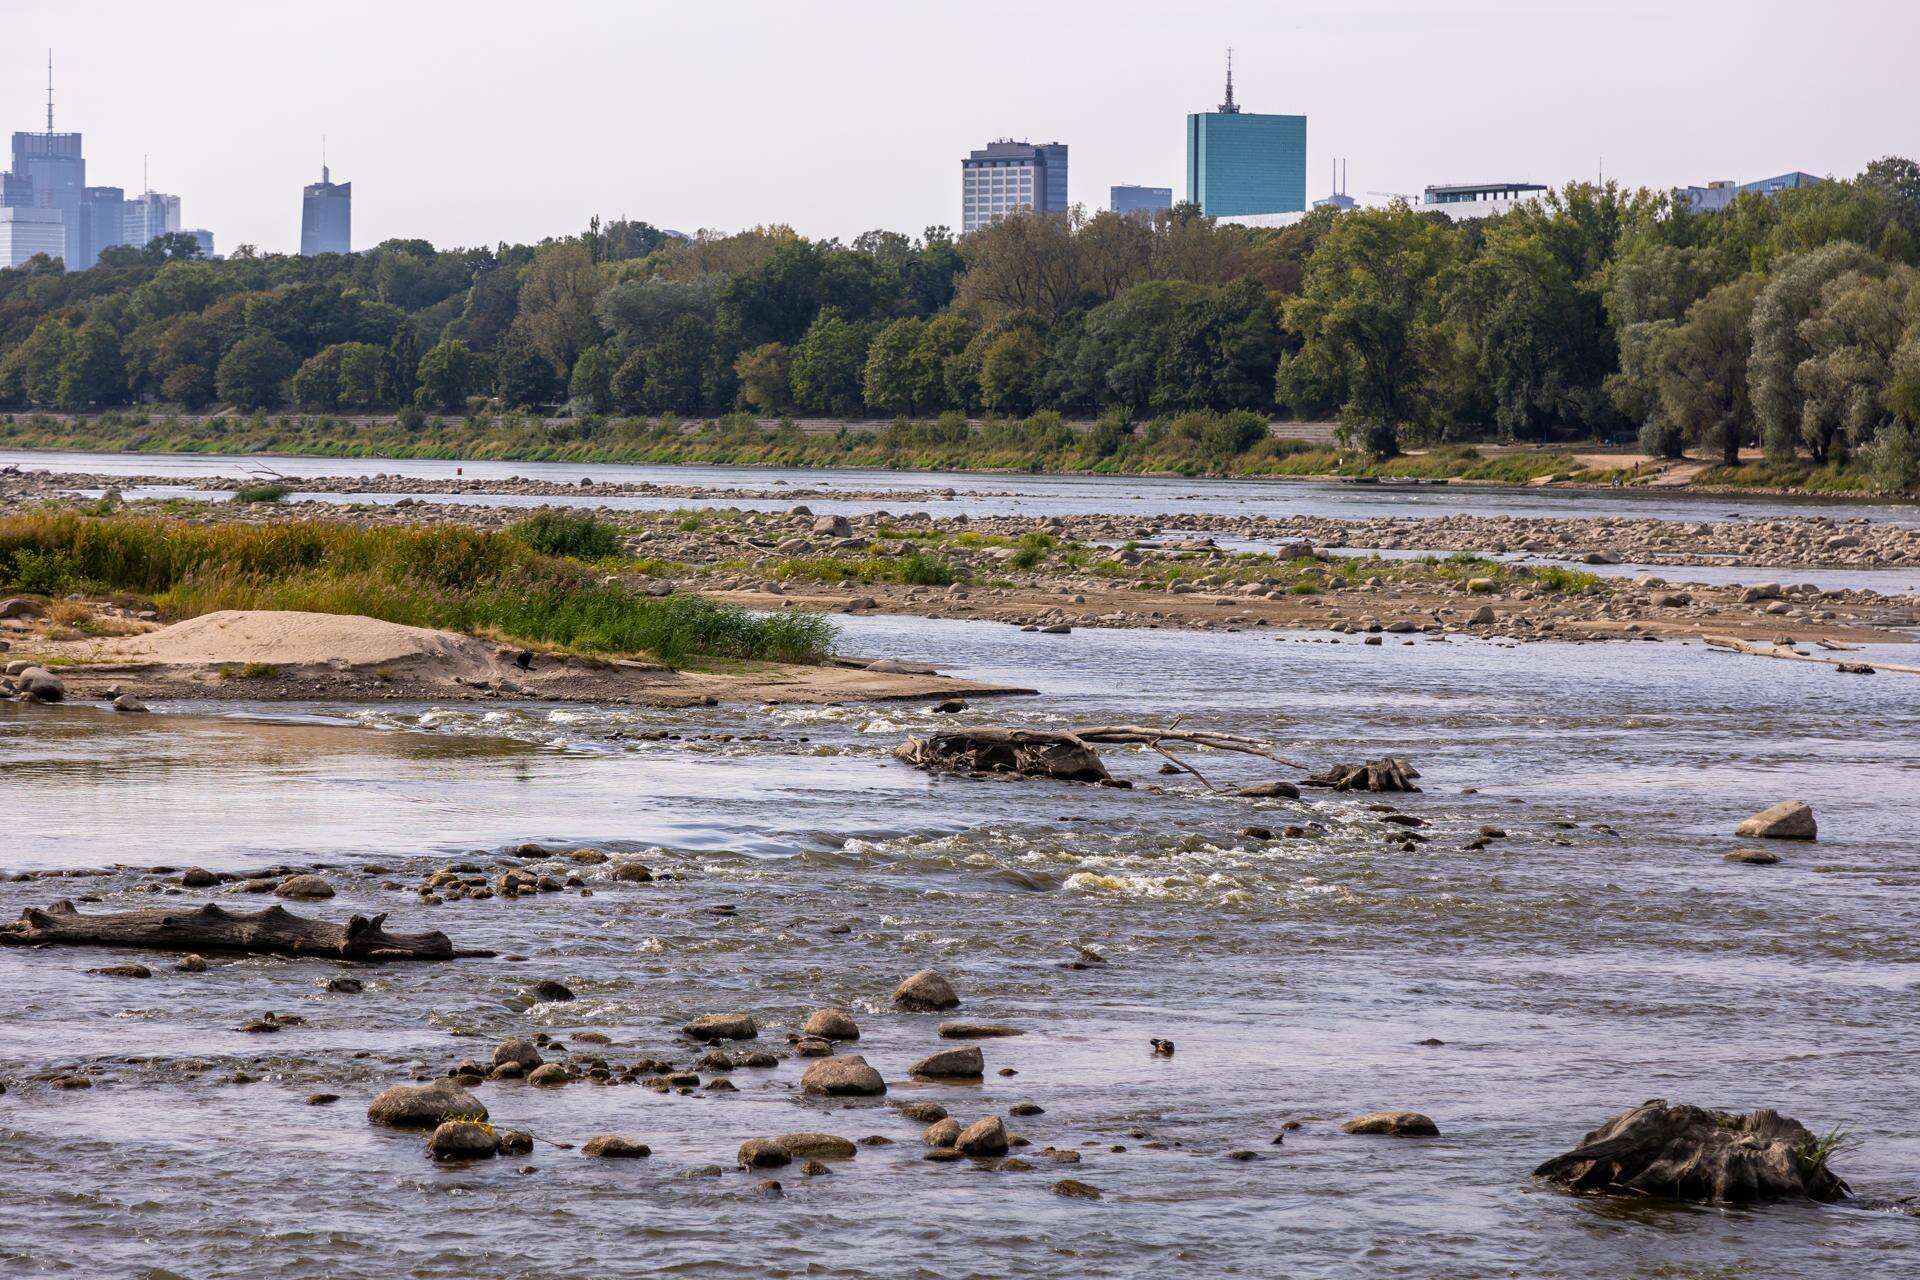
[0,157,1920,472]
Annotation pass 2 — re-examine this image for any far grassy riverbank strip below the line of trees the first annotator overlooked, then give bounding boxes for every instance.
[0,413,1885,497]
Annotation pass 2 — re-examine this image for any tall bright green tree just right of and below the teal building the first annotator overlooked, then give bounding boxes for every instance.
[1281,203,1455,457]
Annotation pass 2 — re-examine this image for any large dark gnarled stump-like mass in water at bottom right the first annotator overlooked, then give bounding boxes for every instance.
[1534,1098,1851,1201]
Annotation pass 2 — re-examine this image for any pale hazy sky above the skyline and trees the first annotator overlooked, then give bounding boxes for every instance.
[0,0,1920,251]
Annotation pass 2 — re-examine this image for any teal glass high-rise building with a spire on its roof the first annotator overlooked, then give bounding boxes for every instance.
[1187,50,1308,217]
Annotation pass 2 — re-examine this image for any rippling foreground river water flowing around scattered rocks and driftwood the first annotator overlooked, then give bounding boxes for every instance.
[0,614,1920,1280]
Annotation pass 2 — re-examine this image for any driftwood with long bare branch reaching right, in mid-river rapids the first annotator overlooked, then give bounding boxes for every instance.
[893,720,1300,791]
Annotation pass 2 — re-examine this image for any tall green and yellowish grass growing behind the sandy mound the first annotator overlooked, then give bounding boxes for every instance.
[0,512,833,662]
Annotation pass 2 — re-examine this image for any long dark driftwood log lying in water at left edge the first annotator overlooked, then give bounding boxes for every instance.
[0,898,493,960]
